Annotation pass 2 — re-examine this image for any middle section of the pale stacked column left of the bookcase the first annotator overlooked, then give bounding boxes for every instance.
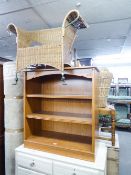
[4,98,24,129]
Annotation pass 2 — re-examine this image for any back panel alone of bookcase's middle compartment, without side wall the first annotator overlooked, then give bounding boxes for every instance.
[42,99,91,114]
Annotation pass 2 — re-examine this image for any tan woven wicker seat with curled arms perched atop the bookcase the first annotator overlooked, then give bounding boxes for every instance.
[8,10,87,71]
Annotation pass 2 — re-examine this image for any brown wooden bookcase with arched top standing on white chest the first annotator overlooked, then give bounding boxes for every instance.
[24,67,98,161]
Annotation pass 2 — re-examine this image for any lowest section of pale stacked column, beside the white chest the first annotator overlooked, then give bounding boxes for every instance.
[5,131,23,175]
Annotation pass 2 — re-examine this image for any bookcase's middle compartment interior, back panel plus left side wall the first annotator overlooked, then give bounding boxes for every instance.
[26,98,92,114]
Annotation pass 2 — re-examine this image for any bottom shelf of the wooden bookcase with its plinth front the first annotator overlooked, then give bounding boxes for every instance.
[25,131,93,161]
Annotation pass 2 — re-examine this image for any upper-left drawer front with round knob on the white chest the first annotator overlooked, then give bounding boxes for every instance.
[16,153,52,175]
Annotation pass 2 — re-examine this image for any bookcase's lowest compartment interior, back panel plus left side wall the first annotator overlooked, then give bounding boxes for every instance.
[27,119,92,137]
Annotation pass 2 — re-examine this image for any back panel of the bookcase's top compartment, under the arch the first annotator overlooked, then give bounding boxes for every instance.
[42,75,92,96]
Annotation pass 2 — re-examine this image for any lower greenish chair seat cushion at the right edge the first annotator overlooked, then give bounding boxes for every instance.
[116,119,131,128]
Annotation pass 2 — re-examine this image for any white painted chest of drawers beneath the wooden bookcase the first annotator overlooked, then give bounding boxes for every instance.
[16,142,107,175]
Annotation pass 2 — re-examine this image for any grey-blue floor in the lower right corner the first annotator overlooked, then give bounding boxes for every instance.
[117,130,131,175]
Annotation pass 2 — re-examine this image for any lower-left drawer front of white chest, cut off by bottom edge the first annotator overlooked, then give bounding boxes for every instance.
[17,167,46,175]
